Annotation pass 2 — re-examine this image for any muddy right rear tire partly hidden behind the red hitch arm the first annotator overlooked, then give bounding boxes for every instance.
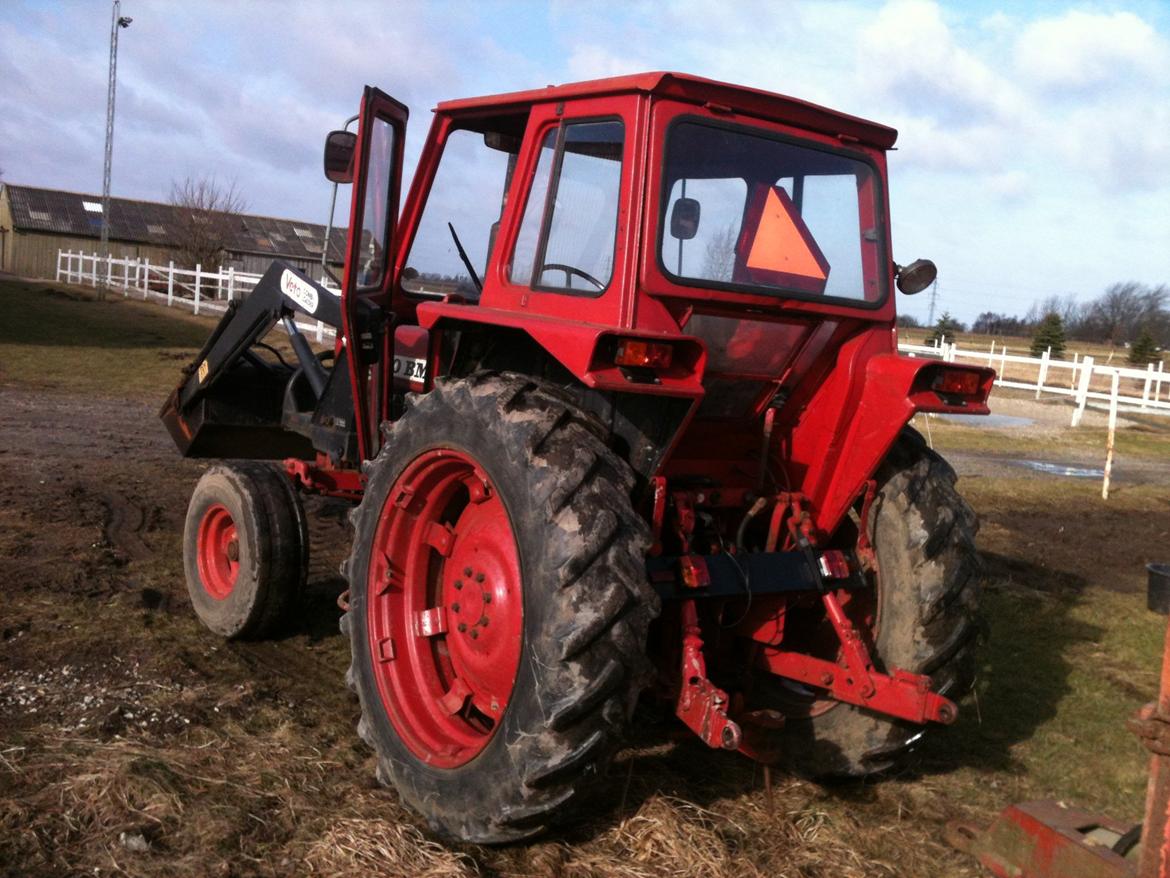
[770,428,982,780]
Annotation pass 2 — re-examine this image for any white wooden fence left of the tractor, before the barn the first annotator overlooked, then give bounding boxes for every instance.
[56,251,337,342]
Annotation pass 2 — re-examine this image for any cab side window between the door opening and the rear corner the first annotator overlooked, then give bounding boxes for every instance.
[509,121,625,293]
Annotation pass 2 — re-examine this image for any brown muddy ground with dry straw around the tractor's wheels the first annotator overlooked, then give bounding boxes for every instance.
[0,285,1170,878]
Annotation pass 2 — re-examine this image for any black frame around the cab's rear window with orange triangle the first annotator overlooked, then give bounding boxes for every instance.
[653,112,890,311]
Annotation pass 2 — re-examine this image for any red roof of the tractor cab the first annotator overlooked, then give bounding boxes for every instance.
[435,71,897,150]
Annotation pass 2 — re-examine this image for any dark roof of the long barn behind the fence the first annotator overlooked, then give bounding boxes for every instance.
[4,184,346,262]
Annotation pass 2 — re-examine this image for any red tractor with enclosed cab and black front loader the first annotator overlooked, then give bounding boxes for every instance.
[163,73,993,843]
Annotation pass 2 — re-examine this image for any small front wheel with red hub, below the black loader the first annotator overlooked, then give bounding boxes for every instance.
[183,461,309,639]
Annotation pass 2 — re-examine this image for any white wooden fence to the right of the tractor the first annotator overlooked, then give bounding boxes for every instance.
[897,342,1170,427]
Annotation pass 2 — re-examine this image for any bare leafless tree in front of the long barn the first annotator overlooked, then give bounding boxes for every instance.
[171,176,248,268]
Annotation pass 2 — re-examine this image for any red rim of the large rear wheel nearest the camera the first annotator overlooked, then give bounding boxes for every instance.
[366,448,524,768]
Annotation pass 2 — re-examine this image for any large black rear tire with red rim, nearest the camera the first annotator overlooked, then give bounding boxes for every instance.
[342,373,658,843]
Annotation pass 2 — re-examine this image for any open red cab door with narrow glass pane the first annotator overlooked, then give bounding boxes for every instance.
[337,85,408,460]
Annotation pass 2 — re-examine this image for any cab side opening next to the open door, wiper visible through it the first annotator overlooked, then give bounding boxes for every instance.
[402,129,523,299]
